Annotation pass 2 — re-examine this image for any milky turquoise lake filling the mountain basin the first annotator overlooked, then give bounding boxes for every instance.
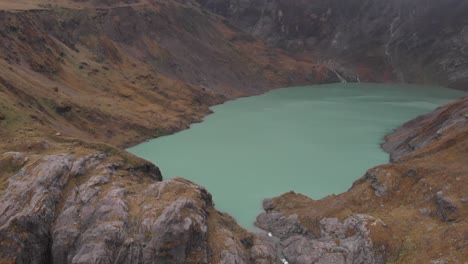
[128,84,466,229]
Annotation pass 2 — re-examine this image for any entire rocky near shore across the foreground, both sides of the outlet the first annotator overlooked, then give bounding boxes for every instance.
[0,95,468,263]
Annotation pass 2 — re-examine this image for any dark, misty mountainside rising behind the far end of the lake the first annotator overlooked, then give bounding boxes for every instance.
[198,0,468,89]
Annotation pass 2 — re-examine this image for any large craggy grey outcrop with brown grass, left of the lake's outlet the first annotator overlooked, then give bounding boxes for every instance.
[0,153,256,264]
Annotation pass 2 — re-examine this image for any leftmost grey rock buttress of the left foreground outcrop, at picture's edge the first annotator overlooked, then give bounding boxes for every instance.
[0,155,72,263]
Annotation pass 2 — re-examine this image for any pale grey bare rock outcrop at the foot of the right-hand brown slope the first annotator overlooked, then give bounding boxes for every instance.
[256,207,385,264]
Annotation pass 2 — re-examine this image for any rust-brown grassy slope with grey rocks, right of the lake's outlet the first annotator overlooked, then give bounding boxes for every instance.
[252,97,468,264]
